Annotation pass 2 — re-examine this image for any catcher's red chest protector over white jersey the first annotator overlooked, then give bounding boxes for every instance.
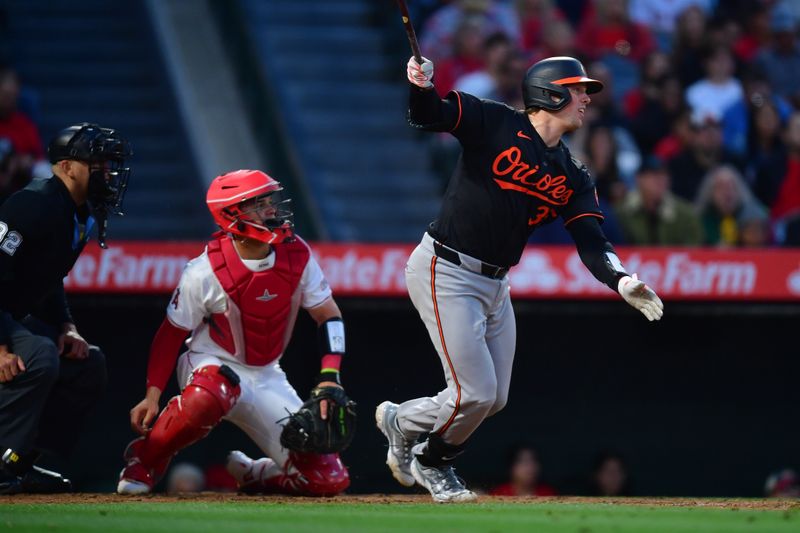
[207,236,310,366]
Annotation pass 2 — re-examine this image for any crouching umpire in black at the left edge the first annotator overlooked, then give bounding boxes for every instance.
[0,123,132,494]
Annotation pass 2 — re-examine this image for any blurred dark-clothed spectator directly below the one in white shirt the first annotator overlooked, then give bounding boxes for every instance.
[669,114,743,201]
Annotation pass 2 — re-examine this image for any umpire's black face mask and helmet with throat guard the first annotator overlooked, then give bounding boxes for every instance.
[47,122,133,248]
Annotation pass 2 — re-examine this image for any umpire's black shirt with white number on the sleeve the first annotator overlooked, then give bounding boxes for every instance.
[0,176,92,344]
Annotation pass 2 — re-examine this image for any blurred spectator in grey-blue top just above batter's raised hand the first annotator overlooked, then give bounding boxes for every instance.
[420,0,519,63]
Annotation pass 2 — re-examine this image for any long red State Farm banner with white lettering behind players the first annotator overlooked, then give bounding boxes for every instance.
[65,242,800,301]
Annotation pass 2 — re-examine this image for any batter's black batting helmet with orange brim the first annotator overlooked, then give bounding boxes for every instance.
[522,57,603,111]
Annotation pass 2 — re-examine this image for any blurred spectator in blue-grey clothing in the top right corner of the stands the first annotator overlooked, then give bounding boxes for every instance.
[756,3,800,108]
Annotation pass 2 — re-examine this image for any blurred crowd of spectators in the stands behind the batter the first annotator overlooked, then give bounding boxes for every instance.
[412,0,800,247]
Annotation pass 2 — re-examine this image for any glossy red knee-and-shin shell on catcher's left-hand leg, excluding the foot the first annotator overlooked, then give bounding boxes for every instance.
[137,365,241,467]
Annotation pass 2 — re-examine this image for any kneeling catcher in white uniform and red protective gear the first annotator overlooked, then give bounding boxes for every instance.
[117,170,355,496]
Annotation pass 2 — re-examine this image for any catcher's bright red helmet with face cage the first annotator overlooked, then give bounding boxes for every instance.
[206,170,294,244]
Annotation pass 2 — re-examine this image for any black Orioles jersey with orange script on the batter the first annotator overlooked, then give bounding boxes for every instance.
[409,90,603,267]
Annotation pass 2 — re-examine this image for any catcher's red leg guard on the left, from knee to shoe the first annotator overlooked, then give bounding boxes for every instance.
[117,365,241,493]
